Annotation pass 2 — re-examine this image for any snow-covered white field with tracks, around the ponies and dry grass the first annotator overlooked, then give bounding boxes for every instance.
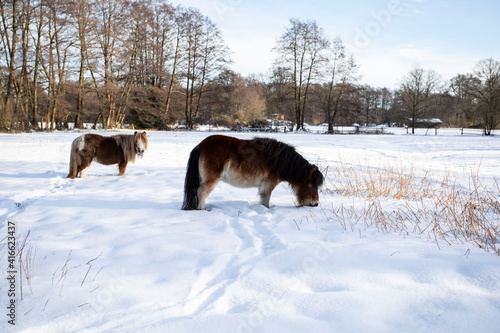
[0,129,500,332]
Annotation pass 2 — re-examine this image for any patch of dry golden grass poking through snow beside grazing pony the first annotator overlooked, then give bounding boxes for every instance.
[323,161,500,255]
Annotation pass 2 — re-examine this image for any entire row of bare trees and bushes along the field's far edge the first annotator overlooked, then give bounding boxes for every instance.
[0,0,500,134]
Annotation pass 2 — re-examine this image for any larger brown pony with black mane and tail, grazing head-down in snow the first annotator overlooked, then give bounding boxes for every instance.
[182,135,324,210]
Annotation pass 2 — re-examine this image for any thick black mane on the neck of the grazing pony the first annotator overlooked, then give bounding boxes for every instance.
[251,138,315,186]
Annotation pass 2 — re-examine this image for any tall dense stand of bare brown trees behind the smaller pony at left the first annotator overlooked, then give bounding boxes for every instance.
[0,0,229,129]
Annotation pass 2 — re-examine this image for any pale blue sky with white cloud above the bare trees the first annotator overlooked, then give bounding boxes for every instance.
[172,0,500,89]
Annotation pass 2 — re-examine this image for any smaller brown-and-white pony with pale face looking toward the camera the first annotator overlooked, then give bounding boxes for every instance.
[68,132,148,178]
